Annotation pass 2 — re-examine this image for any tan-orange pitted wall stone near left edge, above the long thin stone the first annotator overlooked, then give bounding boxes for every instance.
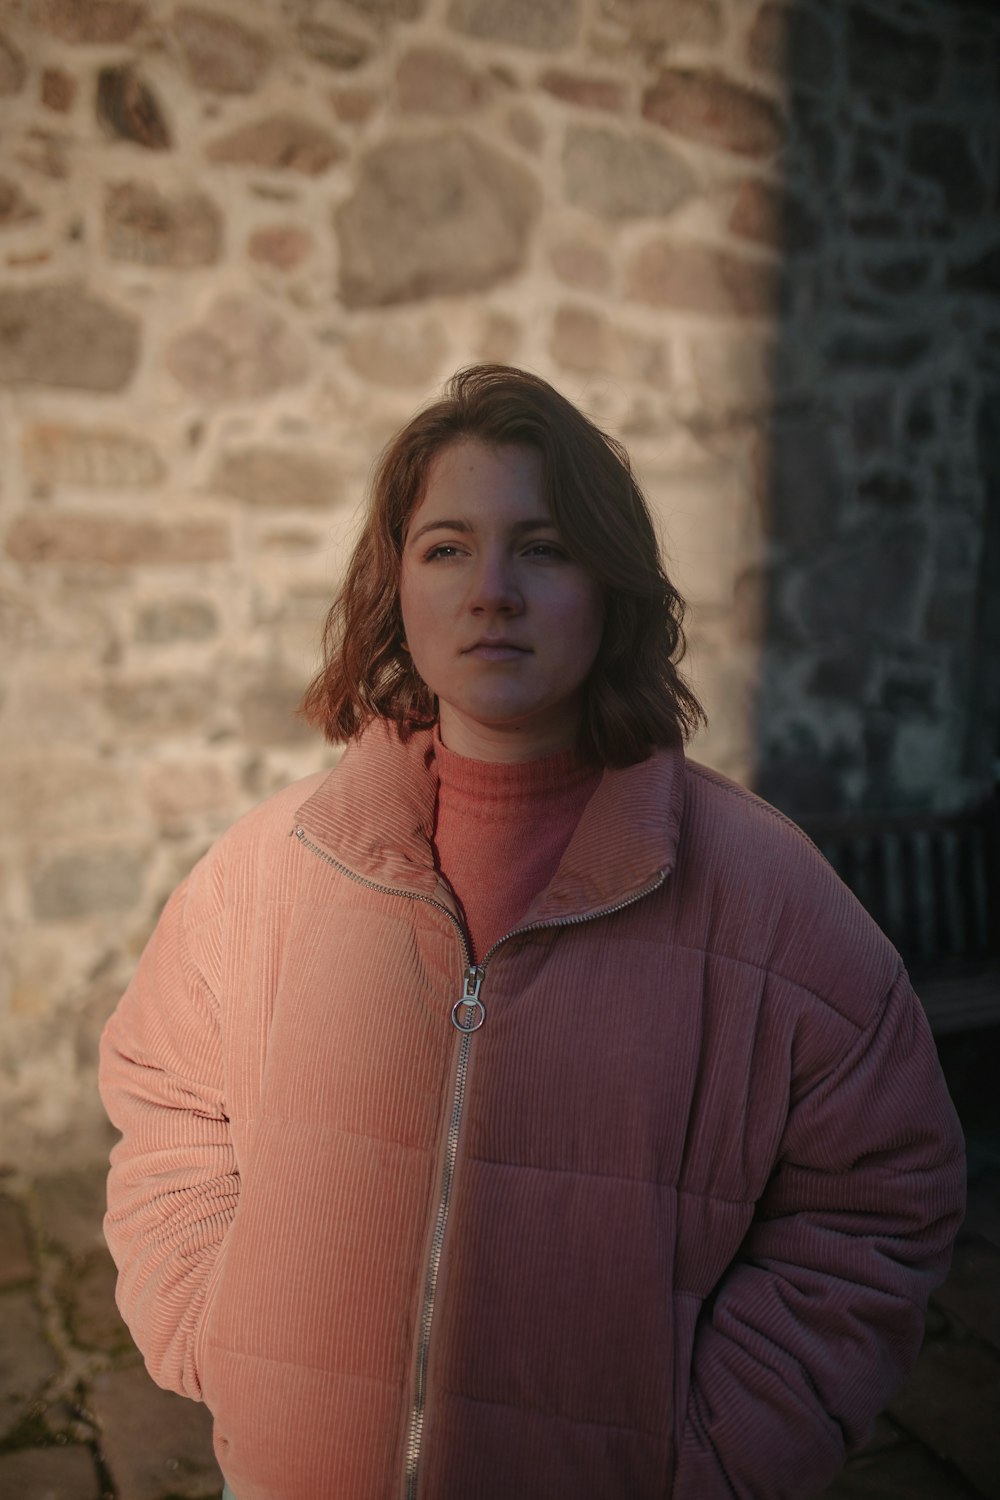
[21,422,166,489]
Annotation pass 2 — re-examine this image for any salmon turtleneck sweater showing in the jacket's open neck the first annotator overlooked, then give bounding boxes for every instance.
[433,735,603,963]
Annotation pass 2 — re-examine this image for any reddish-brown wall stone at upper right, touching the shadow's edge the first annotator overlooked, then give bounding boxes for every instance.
[642,68,786,158]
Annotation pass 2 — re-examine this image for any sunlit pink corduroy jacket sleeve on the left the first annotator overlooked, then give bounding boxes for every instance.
[100,881,240,1400]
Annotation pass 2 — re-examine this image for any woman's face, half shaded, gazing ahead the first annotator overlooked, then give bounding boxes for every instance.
[399,438,604,761]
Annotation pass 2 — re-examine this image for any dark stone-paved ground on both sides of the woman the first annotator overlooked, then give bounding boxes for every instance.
[0,1029,1000,1500]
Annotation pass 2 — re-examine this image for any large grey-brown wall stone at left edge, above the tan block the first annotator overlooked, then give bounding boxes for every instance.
[0,282,139,392]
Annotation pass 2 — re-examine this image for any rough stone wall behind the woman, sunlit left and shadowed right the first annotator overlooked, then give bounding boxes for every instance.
[0,0,1000,1160]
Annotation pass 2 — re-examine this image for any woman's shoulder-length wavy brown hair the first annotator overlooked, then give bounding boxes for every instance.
[301,365,705,767]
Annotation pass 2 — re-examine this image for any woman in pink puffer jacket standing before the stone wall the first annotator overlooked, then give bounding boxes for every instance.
[103,366,964,1500]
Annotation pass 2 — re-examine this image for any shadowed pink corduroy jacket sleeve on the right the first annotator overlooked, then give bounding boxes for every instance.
[673,972,966,1500]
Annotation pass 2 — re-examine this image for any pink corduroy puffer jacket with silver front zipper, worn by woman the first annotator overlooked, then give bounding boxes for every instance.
[102,723,964,1500]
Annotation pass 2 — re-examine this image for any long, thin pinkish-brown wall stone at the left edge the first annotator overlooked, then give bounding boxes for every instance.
[4,513,232,569]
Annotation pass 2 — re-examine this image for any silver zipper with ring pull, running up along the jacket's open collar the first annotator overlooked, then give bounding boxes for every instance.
[295,827,667,1500]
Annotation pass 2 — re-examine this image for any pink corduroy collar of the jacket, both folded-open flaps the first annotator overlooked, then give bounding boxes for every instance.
[297,720,684,926]
